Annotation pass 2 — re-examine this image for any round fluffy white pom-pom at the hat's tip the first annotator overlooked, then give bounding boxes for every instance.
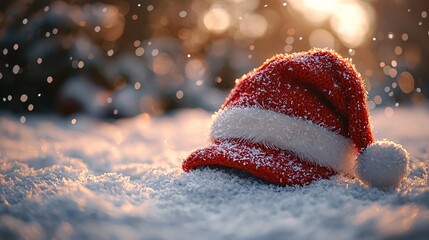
[356,140,410,188]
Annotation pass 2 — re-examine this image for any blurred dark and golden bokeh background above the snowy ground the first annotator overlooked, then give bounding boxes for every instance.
[0,0,429,118]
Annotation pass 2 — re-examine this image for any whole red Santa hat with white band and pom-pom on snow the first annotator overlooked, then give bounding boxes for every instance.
[182,49,409,188]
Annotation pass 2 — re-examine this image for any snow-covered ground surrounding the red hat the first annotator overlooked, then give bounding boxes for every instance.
[0,107,429,239]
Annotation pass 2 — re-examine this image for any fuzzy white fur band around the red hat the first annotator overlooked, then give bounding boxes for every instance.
[211,108,356,176]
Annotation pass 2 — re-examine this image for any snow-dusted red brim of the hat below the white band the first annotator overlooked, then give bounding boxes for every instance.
[183,139,334,185]
